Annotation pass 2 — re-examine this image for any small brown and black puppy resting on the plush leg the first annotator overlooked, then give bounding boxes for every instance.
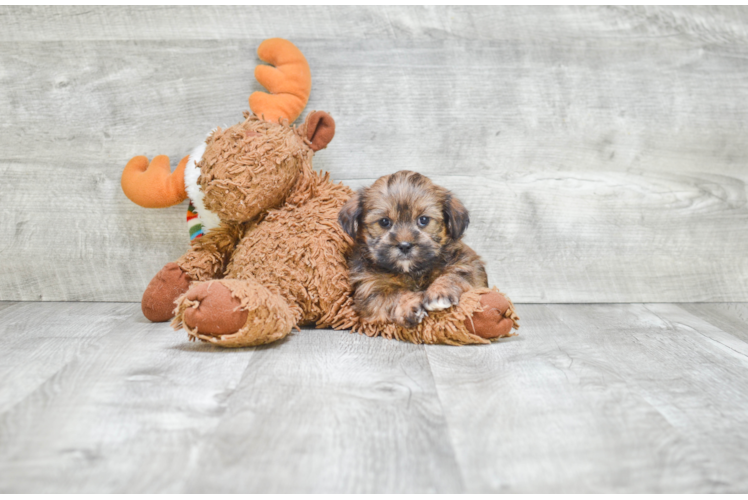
[338,170,488,327]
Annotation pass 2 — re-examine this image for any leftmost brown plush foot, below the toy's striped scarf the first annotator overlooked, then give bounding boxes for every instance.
[140,262,192,323]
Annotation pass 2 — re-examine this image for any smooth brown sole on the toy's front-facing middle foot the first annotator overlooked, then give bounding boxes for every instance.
[184,281,247,336]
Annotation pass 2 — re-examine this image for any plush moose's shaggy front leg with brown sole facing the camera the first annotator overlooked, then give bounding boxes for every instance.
[172,279,298,347]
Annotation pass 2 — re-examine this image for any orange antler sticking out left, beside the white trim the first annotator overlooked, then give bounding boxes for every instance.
[122,155,190,208]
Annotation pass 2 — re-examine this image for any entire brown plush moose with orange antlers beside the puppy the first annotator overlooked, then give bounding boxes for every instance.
[122,38,519,347]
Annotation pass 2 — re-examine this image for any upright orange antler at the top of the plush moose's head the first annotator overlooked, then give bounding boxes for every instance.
[249,38,312,123]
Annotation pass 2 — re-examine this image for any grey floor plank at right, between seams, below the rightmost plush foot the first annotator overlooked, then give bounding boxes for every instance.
[427,304,748,494]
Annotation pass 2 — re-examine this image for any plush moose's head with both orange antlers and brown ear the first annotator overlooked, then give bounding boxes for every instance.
[122,38,335,222]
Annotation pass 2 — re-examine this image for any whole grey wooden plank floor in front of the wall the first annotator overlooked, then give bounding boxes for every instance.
[0,302,748,494]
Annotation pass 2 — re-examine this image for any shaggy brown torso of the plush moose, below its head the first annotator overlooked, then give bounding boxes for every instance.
[172,129,355,345]
